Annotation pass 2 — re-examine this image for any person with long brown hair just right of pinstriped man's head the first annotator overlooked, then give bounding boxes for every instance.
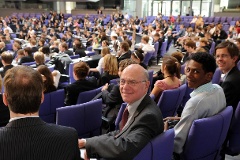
[37,65,57,93]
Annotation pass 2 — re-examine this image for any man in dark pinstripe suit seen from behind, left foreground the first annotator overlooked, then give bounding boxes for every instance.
[0,66,80,160]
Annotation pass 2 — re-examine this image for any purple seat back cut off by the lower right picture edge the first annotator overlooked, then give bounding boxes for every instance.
[226,102,240,156]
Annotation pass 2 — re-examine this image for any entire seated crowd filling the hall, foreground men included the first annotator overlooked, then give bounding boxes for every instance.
[0,12,240,160]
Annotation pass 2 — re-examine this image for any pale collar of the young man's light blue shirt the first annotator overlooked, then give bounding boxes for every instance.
[190,82,220,98]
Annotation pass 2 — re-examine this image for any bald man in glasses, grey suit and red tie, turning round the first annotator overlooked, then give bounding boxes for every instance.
[79,64,163,160]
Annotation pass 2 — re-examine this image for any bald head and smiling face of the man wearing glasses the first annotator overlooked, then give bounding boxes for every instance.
[120,64,150,104]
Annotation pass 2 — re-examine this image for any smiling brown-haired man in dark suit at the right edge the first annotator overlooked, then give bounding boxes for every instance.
[215,41,240,111]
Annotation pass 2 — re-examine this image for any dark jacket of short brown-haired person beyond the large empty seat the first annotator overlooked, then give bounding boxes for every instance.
[64,78,97,106]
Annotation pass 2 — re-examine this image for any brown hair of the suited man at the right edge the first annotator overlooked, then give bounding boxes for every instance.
[214,41,239,63]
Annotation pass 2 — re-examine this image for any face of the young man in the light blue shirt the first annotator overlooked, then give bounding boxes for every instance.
[185,60,213,89]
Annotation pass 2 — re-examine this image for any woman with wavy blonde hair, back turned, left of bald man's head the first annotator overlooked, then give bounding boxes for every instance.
[100,54,119,86]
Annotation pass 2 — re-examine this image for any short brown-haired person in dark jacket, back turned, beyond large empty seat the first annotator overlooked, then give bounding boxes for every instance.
[64,62,97,106]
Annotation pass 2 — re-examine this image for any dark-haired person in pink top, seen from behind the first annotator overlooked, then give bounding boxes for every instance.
[151,56,181,102]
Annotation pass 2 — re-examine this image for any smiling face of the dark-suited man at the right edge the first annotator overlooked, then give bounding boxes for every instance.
[215,48,238,73]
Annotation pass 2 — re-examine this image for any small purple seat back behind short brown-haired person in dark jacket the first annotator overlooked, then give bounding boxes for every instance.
[77,87,102,104]
